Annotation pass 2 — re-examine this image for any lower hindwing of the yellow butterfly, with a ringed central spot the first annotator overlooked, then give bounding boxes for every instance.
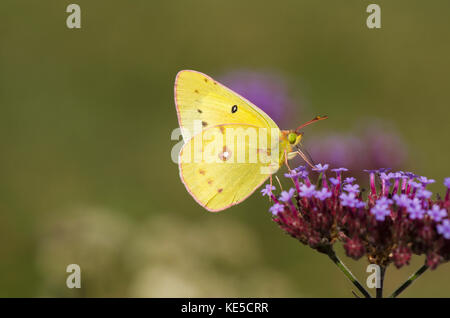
[179,124,279,211]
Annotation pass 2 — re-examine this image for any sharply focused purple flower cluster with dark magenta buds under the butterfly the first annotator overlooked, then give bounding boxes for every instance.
[261,164,450,269]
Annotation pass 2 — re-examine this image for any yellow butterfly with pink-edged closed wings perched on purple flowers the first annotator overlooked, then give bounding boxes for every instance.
[174,70,327,212]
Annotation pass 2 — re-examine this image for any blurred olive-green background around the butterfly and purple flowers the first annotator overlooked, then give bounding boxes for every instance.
[0,0,450,297]
